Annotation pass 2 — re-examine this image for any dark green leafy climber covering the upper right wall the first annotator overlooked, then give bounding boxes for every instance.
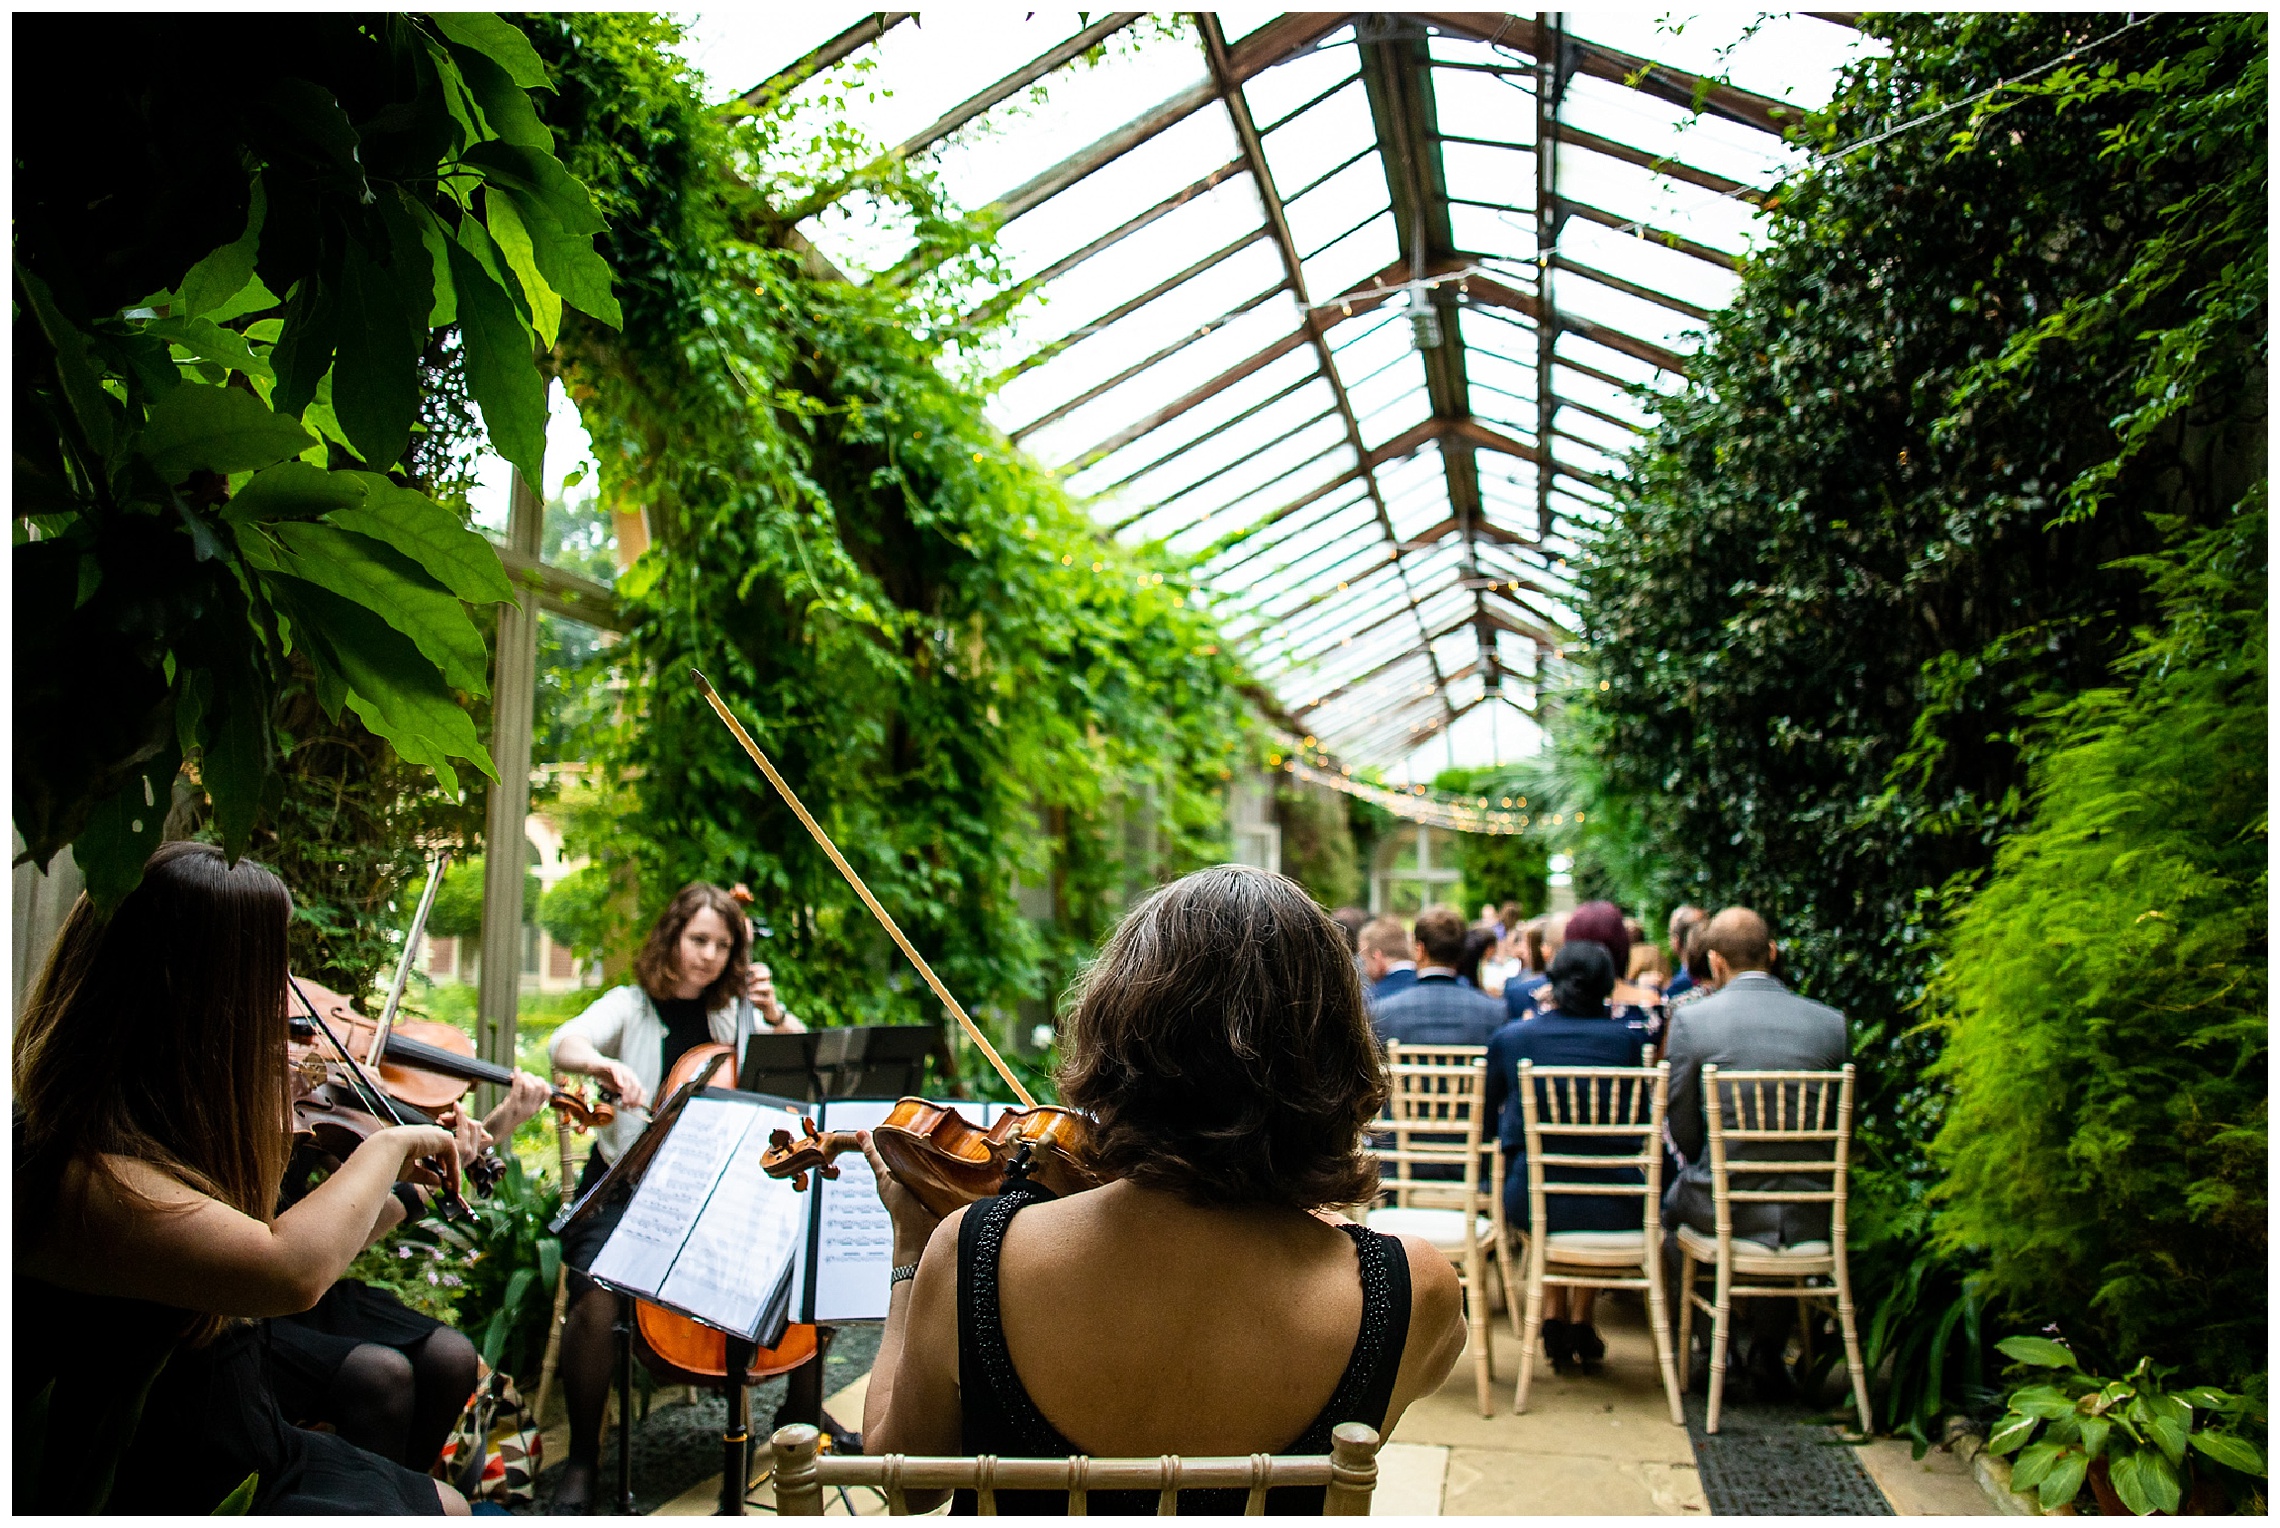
[1575,14,2264,1204]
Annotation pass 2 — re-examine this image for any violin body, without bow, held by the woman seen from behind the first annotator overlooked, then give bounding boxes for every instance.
[759,1097,1101,1216]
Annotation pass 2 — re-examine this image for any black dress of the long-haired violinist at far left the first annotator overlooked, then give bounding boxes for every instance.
[11,1275,442,1517]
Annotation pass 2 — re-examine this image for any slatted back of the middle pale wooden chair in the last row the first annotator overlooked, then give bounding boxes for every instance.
[1518,1060,1671,1247]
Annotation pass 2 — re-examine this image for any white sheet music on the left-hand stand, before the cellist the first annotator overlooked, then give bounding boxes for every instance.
[588,1095,809,1336]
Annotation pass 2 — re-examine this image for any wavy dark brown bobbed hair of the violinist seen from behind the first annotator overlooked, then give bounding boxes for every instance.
[1060,864,1386,1209]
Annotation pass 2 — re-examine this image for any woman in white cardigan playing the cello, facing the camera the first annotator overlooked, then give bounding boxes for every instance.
[547,880,798,1512]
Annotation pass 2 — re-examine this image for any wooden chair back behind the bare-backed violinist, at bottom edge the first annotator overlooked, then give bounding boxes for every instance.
[771,1421,1377,1517]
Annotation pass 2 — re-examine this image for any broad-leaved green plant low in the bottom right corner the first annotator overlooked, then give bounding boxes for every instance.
[1988,1336,2264,1517]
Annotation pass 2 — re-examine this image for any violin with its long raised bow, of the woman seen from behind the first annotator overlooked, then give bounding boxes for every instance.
[689,668,1099,1216]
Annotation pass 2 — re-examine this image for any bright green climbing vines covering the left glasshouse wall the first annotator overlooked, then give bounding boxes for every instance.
[534,14,1245,1067]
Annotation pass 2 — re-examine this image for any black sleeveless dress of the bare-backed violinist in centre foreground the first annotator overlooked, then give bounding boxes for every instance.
[951,1190,1409,1517]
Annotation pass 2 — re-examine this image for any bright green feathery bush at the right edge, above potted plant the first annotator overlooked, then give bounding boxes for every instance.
[1931,495,2271,1382]
